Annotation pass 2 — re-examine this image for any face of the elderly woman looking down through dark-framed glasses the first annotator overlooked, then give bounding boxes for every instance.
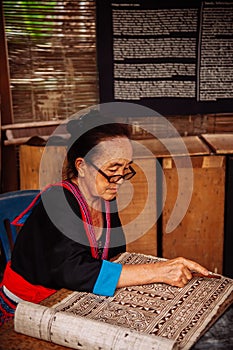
[82,137,133,200]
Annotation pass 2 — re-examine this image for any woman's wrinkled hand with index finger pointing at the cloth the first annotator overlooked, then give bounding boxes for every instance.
[155,257,209,288]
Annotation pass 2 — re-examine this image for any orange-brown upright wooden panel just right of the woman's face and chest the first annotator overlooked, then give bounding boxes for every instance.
[118,158,157,255]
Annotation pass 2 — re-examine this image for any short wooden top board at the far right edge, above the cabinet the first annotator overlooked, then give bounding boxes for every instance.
[202,133,233,154]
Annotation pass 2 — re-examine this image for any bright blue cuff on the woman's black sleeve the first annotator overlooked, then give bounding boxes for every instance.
[93,260,122,297]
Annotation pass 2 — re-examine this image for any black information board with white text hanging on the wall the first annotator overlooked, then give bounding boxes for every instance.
[97,0,233,114]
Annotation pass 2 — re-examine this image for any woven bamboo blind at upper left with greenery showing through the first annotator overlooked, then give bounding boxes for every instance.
[3,0,98,122]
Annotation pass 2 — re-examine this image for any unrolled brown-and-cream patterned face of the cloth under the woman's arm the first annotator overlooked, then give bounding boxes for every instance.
[53,253,233,350]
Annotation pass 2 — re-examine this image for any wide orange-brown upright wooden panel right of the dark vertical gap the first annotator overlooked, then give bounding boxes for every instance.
[162,156,225,273]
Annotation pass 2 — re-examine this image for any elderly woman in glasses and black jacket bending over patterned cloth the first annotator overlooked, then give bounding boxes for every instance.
[0,111,208,322]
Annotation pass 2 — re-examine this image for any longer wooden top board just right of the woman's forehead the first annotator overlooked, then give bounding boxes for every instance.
[137,136,210,158]
